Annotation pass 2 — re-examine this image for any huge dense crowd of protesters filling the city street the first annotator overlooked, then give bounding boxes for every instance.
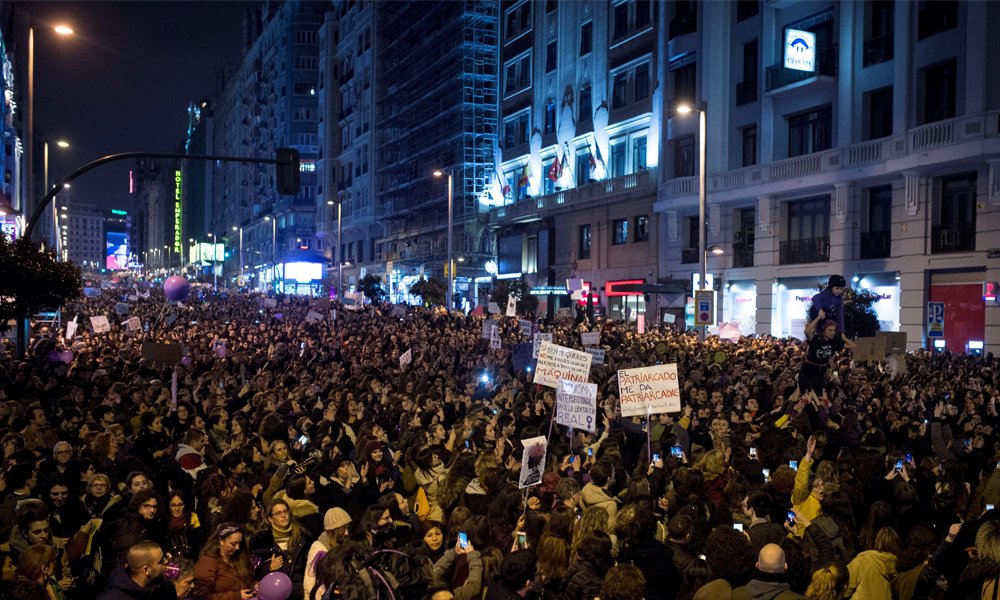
[0,281,1000,600]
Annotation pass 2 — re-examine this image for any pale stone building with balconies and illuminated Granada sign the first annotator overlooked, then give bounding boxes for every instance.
[655,1,1000,352]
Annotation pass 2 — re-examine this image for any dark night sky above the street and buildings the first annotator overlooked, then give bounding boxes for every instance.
[29,1,266,212]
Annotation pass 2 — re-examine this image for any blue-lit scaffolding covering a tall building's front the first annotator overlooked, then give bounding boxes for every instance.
[375,0,499,273]
